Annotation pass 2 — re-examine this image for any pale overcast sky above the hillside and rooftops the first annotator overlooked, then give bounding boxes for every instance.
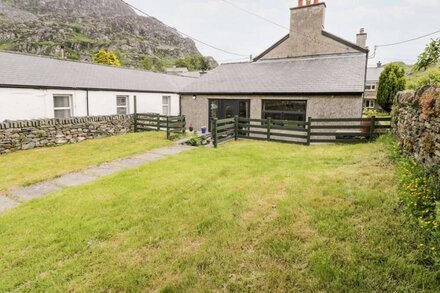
[126,0,440,64]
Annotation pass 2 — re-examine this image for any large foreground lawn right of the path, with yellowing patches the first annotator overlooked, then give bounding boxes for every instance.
[0,136,440,292]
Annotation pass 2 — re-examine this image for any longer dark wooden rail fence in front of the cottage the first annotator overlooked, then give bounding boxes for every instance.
[212,117,391,147]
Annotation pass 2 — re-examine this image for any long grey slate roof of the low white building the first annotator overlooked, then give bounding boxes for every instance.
[0,52,195,93]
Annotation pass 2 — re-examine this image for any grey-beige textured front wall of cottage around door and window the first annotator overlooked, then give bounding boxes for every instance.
[180,94,362,129]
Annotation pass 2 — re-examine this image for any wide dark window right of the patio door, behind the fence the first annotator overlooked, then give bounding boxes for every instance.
[262,100,307,121]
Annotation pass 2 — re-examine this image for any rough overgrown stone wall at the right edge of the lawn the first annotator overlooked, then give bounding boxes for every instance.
[393,87,440,167]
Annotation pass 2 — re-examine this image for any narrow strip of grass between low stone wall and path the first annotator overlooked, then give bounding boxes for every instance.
[0,132,171,193]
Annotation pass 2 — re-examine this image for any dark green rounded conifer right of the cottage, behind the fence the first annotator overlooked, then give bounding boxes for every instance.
[377,64,406,112]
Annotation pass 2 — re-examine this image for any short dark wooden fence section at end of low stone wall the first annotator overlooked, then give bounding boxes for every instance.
[134,113,186,139]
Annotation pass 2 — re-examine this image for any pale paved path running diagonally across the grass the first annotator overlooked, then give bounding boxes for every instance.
[0,145,193,213]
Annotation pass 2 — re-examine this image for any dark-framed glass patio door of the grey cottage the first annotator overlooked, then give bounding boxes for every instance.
[209,99,250,130]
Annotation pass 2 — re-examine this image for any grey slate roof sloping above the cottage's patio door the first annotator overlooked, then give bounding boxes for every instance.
[181,53,367,94]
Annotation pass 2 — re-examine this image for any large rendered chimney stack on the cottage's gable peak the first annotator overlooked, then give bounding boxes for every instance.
[290,0,326,35]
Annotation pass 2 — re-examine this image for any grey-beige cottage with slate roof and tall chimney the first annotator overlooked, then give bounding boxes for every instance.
[180,0,368,129]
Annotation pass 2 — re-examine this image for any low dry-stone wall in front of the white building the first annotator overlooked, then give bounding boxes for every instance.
[0,115,133,154]
